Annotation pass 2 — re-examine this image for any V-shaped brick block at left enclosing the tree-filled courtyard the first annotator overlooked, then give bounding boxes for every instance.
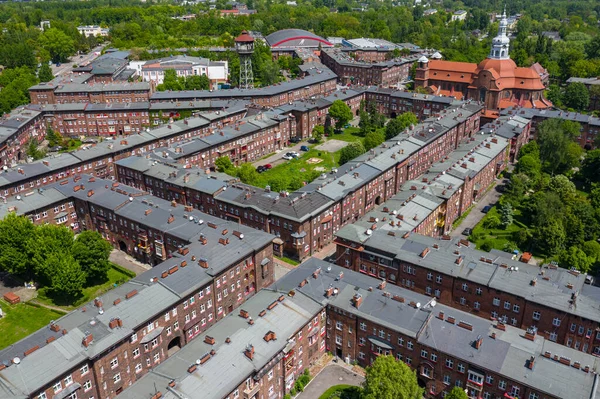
[0,176,273,399]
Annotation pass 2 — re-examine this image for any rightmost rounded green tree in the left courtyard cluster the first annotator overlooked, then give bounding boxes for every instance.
[71,230,112,282]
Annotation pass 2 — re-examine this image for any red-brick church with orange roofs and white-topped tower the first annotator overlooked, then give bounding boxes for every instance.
[415,11,552,117]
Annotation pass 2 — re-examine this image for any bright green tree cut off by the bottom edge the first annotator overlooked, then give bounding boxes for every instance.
[361,355,424,399]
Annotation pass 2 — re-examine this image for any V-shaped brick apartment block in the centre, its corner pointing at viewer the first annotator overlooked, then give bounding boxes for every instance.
[118,104,481,259]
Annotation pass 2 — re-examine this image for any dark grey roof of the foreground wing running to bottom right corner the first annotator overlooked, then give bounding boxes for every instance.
[282,259,599,398]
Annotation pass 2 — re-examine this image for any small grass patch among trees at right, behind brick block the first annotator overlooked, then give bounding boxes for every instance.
[469,206,527,252]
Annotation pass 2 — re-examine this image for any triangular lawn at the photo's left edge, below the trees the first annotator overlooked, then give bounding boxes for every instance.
[0,300,62,349]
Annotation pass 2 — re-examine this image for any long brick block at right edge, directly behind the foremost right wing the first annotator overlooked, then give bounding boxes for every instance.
[336,224,600,355]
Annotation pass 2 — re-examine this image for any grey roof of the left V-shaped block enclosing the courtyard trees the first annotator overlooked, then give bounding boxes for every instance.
[0,175,273,397]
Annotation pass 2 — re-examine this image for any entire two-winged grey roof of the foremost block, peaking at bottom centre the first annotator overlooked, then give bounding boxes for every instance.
[108,258,599,399]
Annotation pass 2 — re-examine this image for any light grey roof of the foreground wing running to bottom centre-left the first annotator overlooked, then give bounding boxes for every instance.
[123,289,321,399]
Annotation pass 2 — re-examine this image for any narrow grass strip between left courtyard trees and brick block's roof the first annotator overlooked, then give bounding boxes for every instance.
[36,265,134,311]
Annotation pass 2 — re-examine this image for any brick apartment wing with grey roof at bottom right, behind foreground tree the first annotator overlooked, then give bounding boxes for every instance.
[277,259,598,399]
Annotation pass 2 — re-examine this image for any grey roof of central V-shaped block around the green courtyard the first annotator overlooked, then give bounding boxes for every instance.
[111,103,481,222]
